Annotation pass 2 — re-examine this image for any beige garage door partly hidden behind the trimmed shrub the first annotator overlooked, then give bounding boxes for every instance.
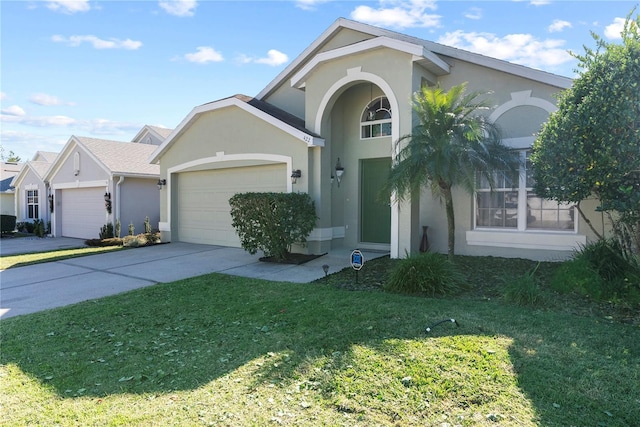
[177,164,287,247]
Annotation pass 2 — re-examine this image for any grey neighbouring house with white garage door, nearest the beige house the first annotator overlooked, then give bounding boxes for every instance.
[44,136,160,239]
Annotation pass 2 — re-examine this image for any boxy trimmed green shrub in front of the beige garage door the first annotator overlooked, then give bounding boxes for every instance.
[229,193,317,260]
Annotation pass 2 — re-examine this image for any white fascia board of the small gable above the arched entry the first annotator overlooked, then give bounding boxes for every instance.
[291,36,449,88]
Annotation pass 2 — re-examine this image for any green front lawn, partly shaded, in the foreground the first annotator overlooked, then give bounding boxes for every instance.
[0,257,640,426]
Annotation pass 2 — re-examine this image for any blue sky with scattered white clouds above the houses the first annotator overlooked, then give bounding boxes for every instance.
[0,0,638,161]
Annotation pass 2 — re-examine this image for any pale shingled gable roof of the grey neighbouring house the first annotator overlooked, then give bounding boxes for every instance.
[45,135,160,181]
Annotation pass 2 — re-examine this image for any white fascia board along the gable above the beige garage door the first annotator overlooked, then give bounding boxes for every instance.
[149,97,324,163]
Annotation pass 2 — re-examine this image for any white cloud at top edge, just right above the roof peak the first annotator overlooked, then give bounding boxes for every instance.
[351,0,441,28]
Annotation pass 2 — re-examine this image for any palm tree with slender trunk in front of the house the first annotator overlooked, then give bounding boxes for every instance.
[385,83,520,259]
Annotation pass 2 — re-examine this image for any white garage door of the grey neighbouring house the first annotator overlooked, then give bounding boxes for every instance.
[56,187,107,239]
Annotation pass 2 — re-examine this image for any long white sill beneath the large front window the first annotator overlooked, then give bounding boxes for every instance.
[466,230,587,251]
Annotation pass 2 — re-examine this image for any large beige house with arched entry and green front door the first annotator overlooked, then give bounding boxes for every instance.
[150,19,590,259]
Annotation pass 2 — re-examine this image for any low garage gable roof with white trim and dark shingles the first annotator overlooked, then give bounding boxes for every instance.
[149,95,324,163]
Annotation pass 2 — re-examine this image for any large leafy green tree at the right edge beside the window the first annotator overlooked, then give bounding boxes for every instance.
[531,9,640,258]
